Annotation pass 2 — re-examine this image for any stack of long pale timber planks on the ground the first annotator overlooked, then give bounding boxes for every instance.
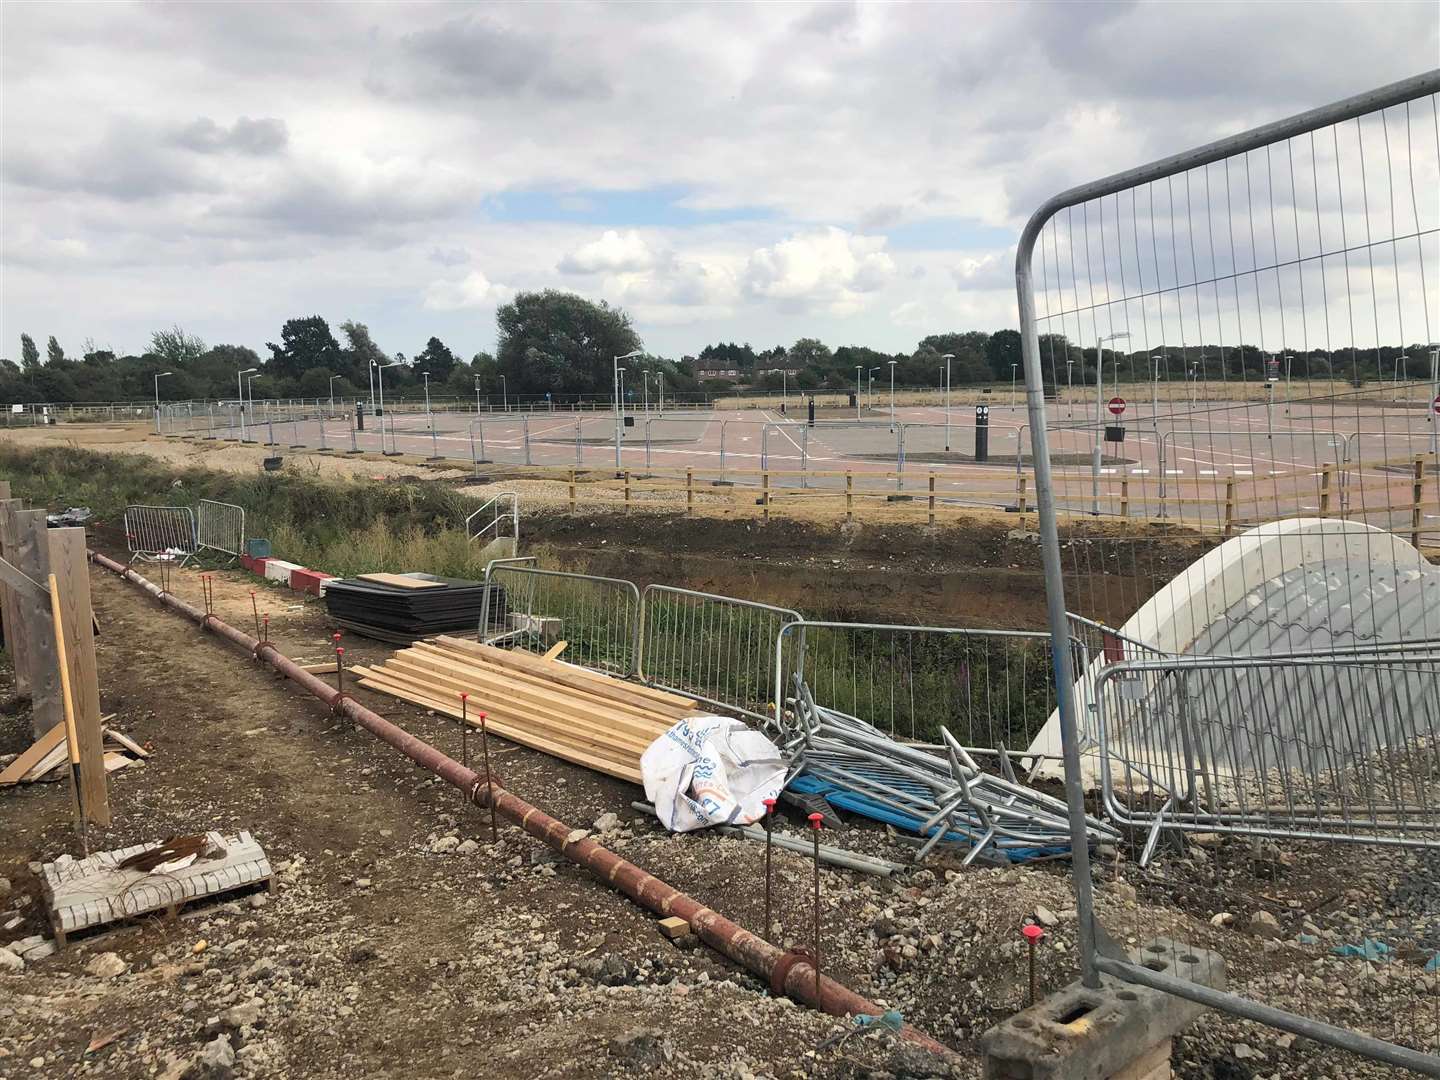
[354,636,704,783]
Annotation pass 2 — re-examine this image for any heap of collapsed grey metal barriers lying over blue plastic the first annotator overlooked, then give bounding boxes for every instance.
[778,675,1119,865]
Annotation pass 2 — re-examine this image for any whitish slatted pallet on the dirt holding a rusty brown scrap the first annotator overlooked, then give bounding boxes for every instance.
[40,832,274,948]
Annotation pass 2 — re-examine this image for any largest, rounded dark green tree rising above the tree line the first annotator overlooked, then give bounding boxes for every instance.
[495,289,641,393]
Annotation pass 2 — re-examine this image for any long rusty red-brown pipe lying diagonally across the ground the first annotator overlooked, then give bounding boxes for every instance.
[91,552,953,1057]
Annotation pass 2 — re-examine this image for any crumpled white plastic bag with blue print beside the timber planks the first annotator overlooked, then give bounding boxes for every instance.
[639,716,785,832]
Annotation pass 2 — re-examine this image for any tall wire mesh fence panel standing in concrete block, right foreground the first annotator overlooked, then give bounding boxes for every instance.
[1015,72,1440,1073]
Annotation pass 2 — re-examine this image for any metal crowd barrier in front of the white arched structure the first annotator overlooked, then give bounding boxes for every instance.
[1096,642,1440,861]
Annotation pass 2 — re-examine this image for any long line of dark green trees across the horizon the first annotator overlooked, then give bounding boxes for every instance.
[0,289,1430,403]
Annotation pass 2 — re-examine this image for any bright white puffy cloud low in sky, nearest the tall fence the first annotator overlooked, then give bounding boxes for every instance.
[743,226,896,315]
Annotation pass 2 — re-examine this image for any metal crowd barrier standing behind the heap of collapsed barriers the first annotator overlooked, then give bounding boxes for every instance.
[775,622,1056,753]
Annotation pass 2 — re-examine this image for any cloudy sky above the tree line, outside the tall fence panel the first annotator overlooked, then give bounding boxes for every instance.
[0,0,1440,359]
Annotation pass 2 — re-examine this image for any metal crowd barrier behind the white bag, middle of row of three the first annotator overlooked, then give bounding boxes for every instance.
[639,585,801,720]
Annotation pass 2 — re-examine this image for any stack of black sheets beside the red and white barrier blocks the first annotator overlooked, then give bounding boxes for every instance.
[325,573,505,644]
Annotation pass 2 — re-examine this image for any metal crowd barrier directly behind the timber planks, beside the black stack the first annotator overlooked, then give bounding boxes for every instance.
[485,563,641,675]
